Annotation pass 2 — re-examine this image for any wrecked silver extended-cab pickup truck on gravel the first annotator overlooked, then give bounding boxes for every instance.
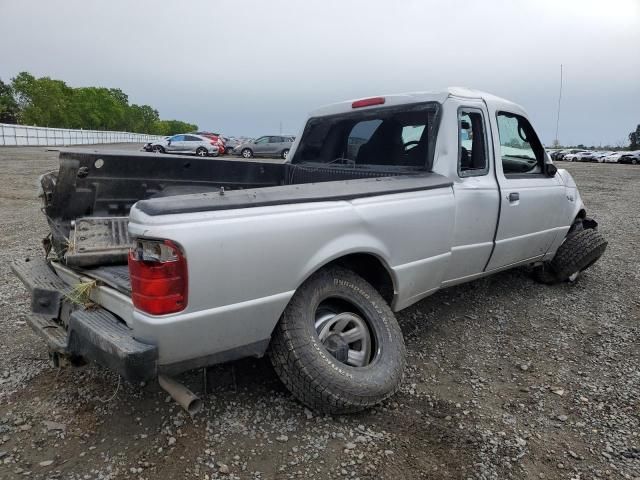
[13,88,607,413]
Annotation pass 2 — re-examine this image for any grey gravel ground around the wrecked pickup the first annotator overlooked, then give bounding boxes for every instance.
[0,147,640,479]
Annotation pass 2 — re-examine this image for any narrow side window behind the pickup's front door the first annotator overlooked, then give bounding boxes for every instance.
[458,109,489,177]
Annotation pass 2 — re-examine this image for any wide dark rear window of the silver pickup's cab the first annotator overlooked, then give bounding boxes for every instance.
[291,102,440,170]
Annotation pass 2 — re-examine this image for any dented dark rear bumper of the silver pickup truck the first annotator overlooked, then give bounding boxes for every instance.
[11,259,158,382]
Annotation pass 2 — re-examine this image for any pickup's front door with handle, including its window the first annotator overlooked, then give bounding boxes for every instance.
[487,111,566,271]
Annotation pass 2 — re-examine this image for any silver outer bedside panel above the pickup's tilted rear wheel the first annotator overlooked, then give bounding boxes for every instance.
[129,187,455,364]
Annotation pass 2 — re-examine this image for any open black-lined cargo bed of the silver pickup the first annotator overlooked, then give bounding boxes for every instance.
[41,150,451,266]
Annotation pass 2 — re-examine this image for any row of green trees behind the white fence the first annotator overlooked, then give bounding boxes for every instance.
[0,72,198,135]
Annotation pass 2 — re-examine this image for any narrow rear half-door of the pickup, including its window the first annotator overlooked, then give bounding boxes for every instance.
[444,104,500,285]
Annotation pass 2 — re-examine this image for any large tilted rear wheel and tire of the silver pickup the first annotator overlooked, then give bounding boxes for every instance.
[269,267,406,414]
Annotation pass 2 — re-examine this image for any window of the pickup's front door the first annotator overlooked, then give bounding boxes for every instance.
[497,112,544,176]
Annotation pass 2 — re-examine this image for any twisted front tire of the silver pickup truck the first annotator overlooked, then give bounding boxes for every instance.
[534,229,607,284]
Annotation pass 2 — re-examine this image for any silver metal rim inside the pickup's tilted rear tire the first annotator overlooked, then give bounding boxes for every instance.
[315,307,373,367]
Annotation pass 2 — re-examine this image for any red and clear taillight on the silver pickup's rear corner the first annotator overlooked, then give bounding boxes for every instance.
[129,240,187,315]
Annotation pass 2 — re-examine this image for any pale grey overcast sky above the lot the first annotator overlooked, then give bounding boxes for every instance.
[0,0,640,145]
